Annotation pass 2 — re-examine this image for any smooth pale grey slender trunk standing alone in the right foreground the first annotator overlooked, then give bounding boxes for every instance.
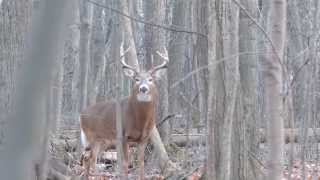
[263,0,286,180]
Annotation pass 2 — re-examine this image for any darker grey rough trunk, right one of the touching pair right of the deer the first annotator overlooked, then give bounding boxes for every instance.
[238,0,258,180]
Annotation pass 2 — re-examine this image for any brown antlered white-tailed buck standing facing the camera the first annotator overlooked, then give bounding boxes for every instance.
[80,48,168,179]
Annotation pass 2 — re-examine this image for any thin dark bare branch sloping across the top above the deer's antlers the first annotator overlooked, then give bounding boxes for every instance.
[87,0,207,39]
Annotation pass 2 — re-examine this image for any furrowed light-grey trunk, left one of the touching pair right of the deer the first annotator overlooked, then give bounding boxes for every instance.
[213,1,239,180]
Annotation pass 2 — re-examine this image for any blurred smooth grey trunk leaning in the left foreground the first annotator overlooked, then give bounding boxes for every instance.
[0,1,71,179]
